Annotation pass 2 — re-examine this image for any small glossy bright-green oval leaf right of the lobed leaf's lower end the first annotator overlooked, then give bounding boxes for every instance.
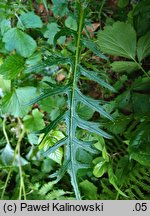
[93,158,107,178]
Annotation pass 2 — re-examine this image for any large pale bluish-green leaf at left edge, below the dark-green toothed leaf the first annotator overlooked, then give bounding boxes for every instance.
[2,86,36,117]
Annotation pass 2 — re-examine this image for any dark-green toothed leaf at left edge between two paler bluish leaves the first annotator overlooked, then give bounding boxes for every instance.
[0,54,25,80]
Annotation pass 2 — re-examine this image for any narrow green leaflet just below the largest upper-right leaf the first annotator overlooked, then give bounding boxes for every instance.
[111,61,139,73]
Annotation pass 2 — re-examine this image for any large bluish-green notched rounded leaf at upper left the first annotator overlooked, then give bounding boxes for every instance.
[3,28,37,57]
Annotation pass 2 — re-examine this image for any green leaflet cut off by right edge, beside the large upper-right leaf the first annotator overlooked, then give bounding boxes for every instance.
[137,31,150,62]
